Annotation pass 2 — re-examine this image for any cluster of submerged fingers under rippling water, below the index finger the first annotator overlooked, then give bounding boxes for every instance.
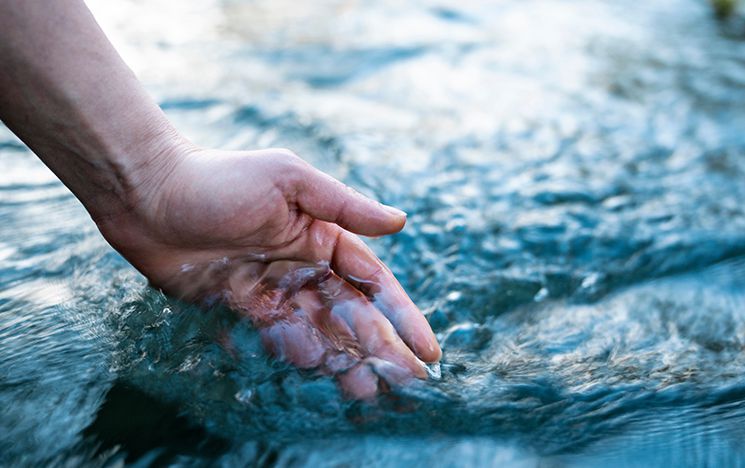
[250,280,426,399]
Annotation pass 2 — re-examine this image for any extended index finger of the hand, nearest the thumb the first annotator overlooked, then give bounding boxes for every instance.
[331,232,442,362]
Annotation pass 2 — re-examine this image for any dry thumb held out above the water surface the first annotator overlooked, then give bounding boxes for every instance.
[292,156,406,236]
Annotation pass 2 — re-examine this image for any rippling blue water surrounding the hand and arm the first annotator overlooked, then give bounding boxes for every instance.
[0,0,745,466]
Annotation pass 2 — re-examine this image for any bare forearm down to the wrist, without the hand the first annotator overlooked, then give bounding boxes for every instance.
[0,0,182,218]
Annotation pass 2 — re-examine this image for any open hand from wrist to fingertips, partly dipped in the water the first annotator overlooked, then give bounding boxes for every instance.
[97,145,441,398]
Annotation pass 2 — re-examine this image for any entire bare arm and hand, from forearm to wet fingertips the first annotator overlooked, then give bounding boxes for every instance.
[0,0,441,398]
